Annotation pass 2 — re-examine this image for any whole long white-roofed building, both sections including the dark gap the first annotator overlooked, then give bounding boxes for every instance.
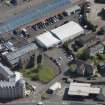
[36,21,84,48]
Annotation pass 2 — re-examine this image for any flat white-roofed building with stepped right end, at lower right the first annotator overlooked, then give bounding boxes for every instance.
[68,82,100,96]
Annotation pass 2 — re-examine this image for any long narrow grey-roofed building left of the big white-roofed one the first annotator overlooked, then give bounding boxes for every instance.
[3,43,37,67]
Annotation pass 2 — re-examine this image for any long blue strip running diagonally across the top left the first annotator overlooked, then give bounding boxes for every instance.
[0,0,71,34]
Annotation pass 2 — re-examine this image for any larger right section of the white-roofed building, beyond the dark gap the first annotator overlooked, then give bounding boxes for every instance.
[52,21,84,42]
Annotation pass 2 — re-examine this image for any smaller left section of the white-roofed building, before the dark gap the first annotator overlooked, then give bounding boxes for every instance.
[36,32,60,48]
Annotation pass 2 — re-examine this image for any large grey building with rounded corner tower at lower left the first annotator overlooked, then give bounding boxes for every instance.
[0,63,26,99]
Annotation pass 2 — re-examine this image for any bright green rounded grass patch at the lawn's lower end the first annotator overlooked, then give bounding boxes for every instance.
[38,67,55,83]
